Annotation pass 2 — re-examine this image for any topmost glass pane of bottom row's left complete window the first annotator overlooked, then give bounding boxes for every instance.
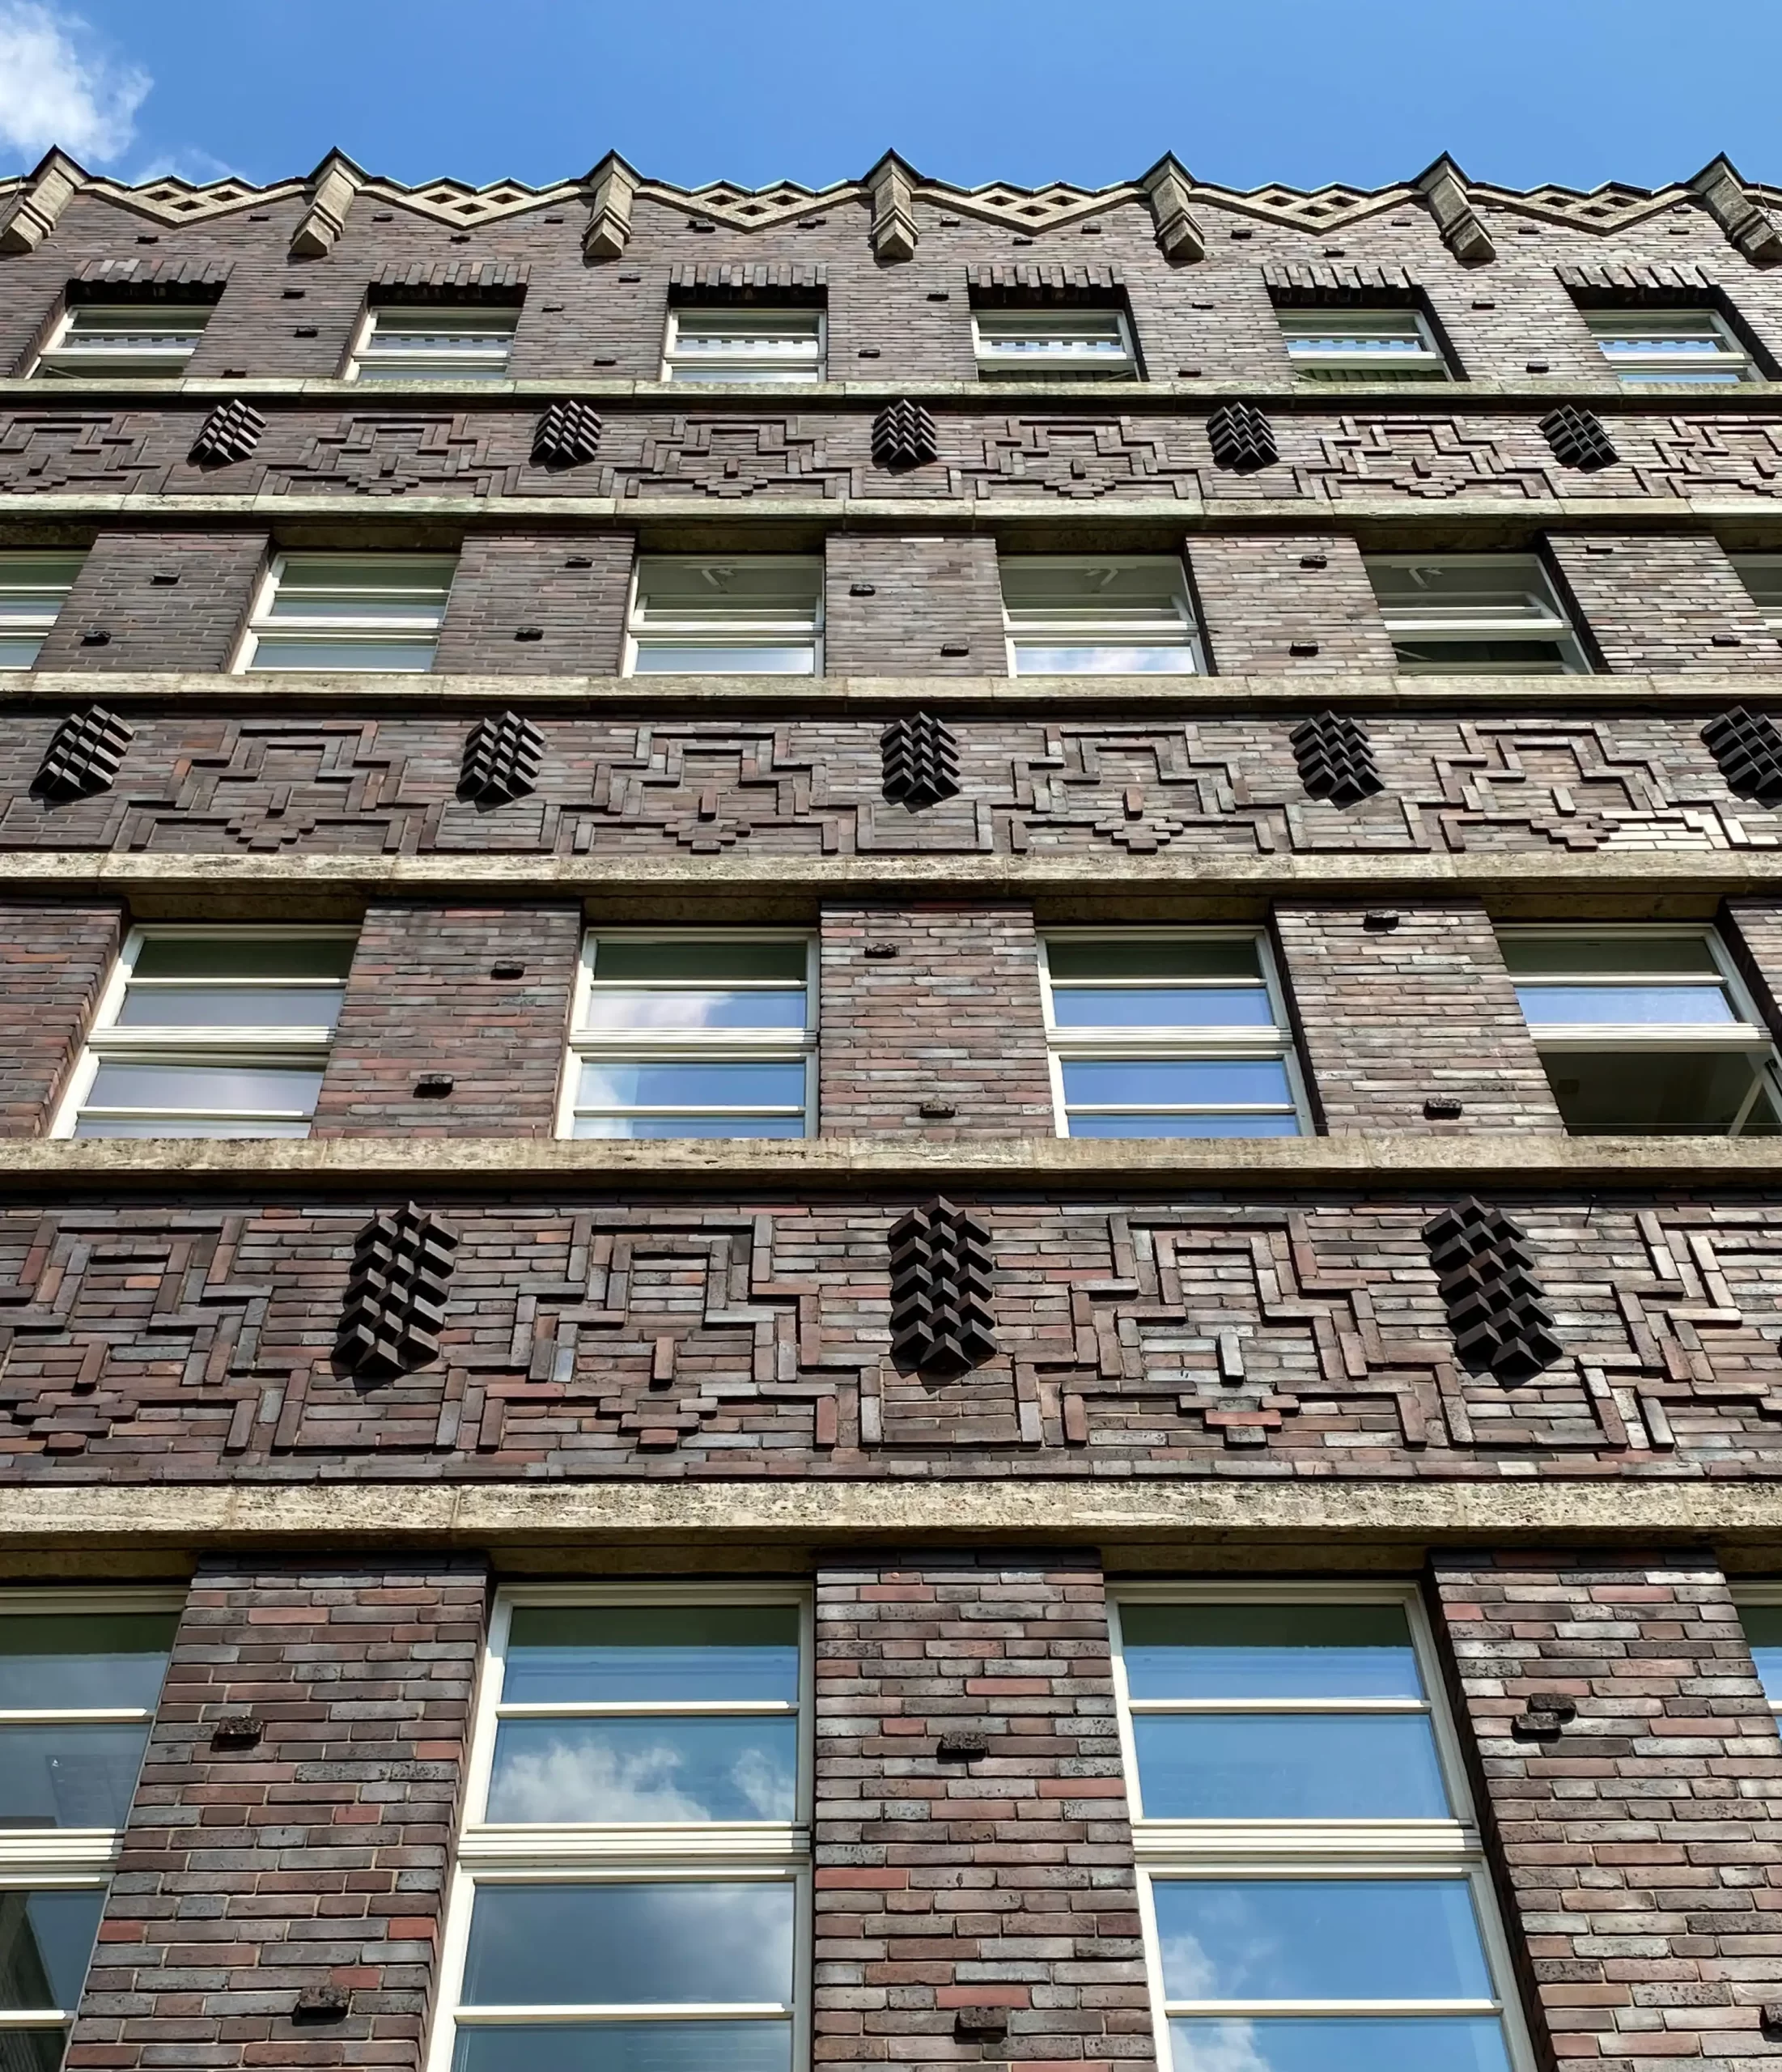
[502,1603,798,1705]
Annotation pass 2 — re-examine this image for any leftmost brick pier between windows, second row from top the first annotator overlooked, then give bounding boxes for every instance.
[37,530,267,671]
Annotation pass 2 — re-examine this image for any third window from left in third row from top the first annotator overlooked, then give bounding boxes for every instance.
[1042,928,1299,1137]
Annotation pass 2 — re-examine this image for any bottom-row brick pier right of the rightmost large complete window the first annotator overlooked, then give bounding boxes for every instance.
[1434,1552,1782,2072]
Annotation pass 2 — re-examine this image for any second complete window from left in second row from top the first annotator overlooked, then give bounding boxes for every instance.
[626,554,823,676]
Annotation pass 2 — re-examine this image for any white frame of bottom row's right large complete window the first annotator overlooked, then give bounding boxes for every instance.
[1109,1581,1535,2072]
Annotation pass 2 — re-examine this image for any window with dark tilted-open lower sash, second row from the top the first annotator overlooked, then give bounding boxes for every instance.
[1368,554,1589,676]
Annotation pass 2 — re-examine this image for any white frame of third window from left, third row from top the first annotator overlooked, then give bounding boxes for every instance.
[1040,928,1309,1144]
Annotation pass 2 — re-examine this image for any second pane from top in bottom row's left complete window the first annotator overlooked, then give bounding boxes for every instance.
[489,1717,798,1821]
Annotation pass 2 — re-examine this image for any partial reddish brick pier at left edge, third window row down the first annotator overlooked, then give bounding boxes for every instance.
[0,899,121,1137]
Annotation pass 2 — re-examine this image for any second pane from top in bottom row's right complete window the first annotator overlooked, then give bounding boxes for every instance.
[1131,1712,1449,1819]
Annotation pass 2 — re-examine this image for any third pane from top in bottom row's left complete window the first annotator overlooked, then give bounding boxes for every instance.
[465,1879,796,2008]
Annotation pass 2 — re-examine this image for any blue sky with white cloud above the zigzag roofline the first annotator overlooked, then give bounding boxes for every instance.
[0,0,1782,186]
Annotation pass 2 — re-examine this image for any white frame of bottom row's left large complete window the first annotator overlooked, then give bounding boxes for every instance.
[426,1583,817,2072]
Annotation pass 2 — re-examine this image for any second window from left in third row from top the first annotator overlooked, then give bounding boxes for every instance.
[562,930,817,1137]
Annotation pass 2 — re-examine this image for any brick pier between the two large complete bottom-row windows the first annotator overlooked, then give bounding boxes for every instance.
[813,1552,1154,2072]
